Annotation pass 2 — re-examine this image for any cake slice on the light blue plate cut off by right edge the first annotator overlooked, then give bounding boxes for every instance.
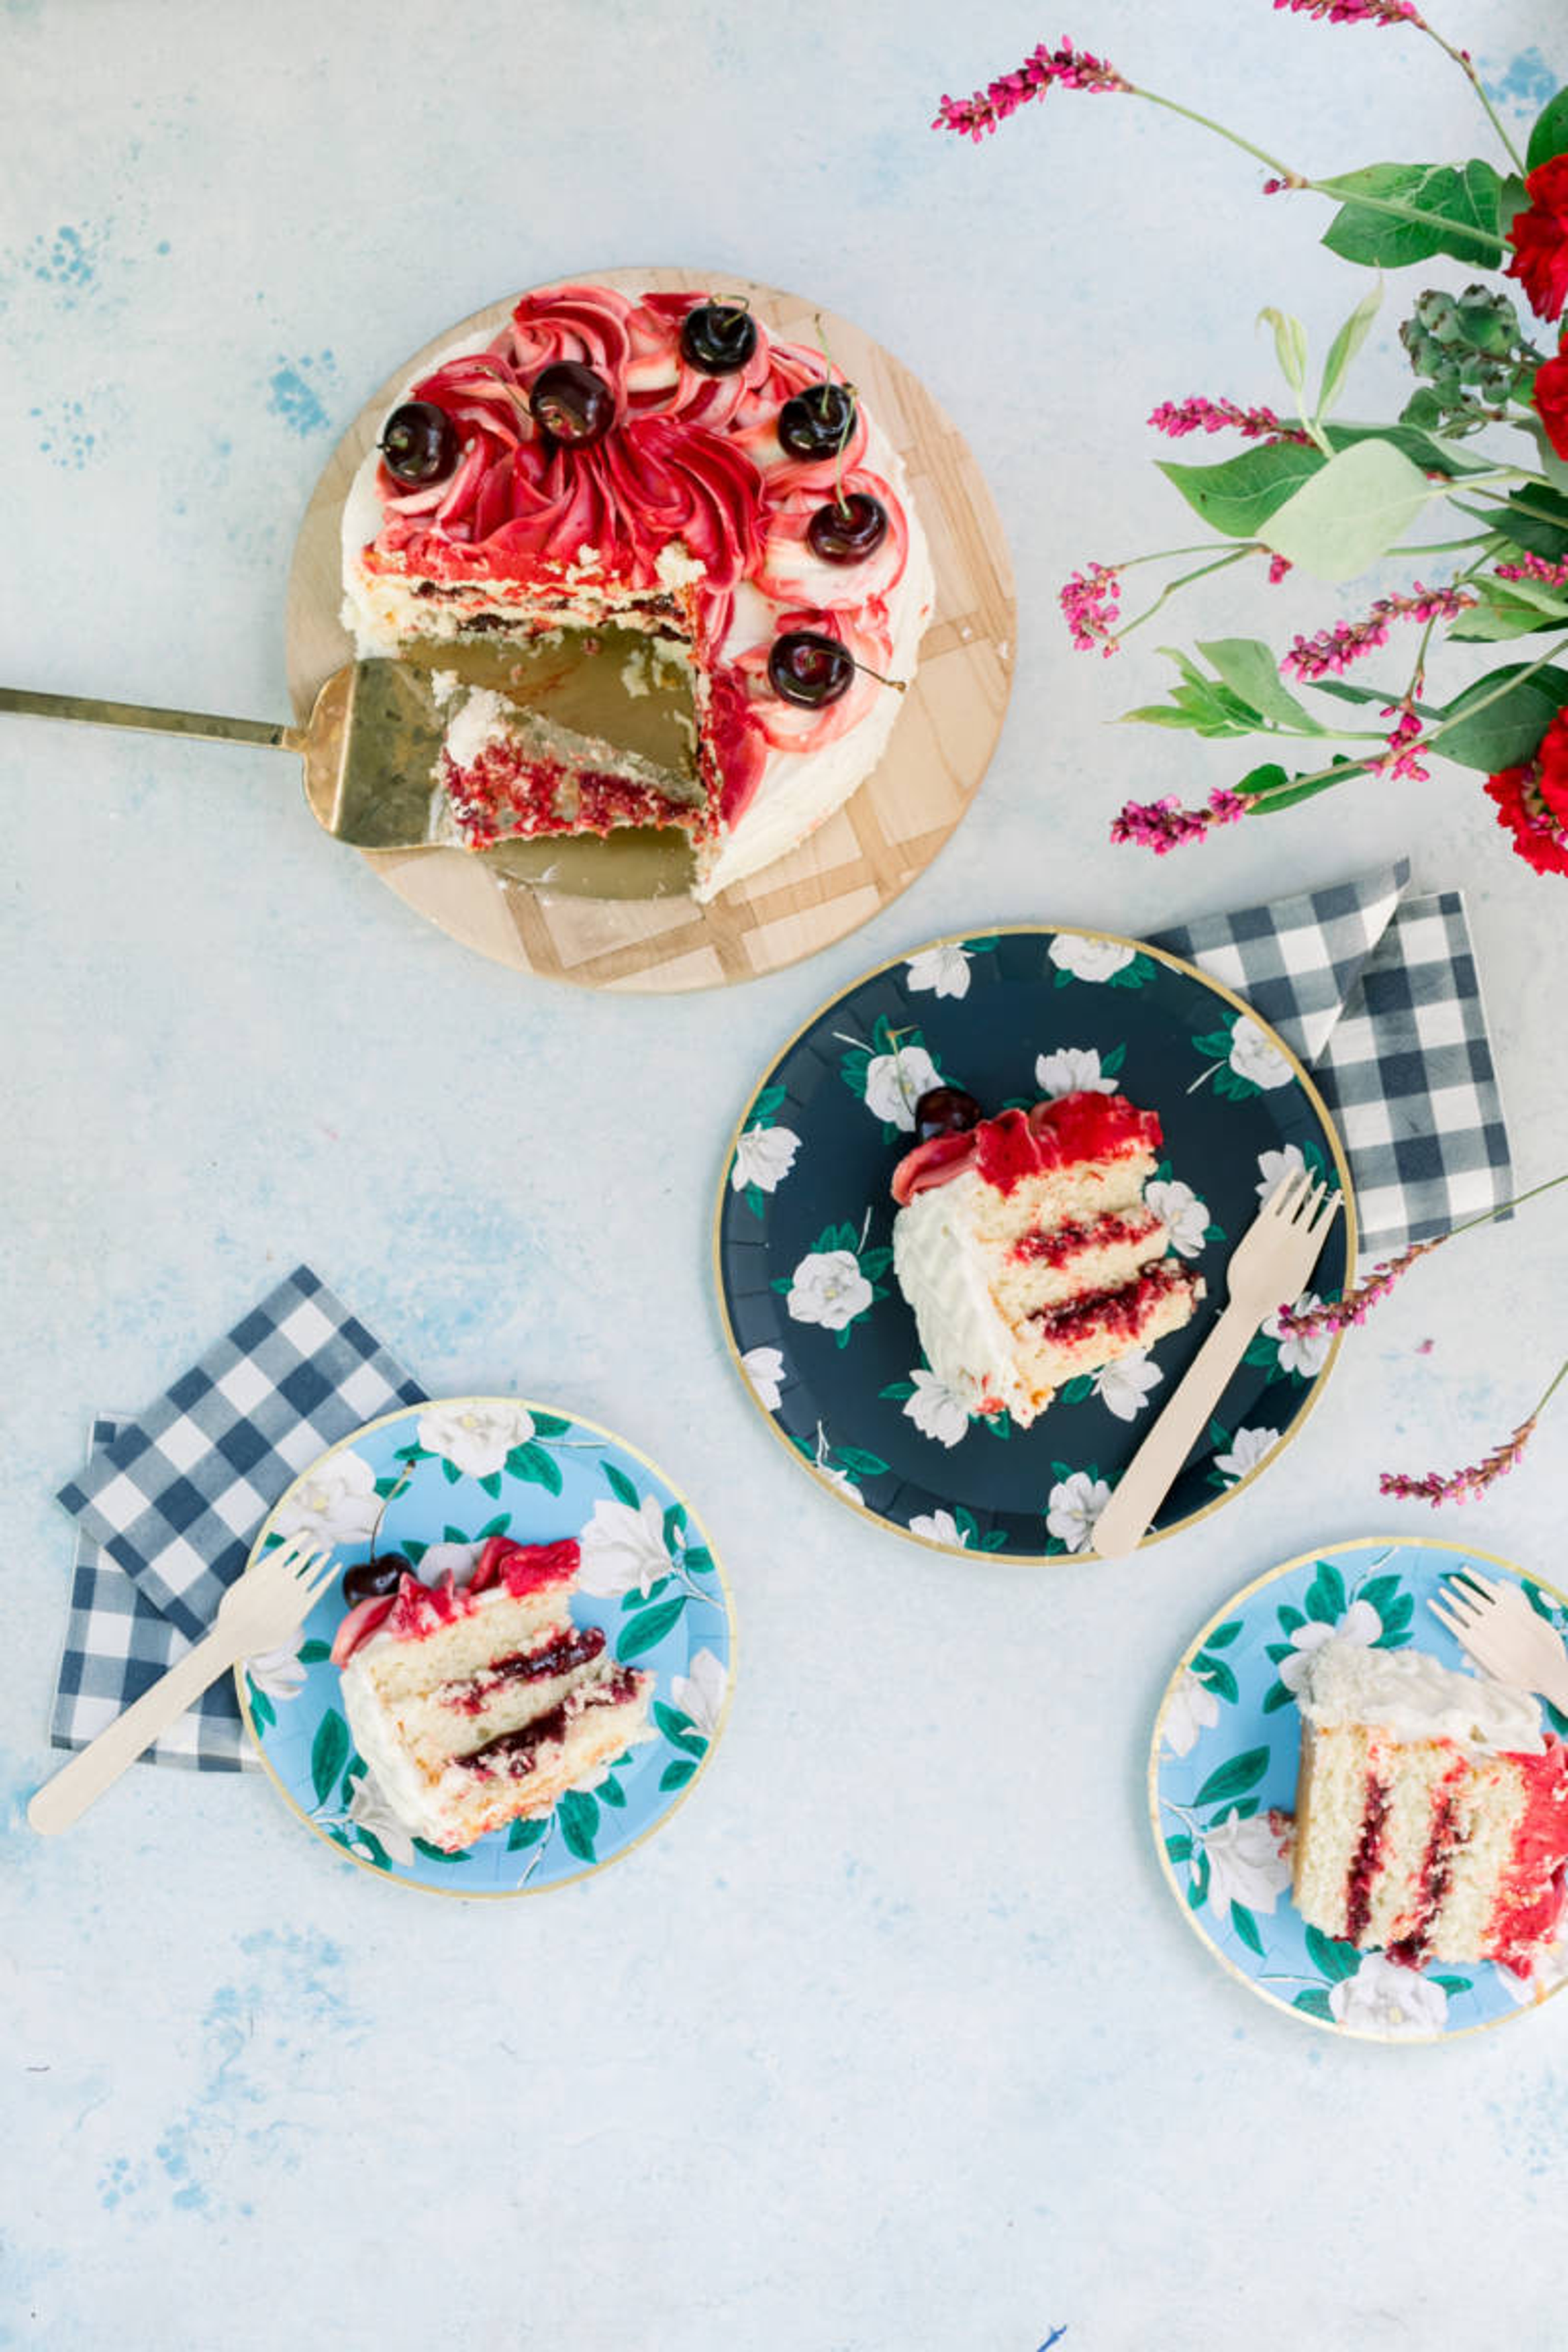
[1295,1637,1568,1976]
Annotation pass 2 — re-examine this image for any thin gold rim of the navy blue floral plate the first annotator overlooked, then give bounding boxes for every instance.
[710,922,1356,1569]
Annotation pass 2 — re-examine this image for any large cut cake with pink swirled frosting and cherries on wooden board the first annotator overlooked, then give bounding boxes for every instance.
[343,285,933,898]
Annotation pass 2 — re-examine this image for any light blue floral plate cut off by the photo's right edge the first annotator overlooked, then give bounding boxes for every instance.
[1149,1536,1568,2042]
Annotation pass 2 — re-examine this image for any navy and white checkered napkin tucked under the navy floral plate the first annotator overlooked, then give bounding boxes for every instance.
[1154,861,1514,1258]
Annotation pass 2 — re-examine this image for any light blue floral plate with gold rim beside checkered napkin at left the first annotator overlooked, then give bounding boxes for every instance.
[235,1397,736,1896]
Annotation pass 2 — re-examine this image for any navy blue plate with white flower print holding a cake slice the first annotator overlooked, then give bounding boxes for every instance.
[715,927,1354,1559]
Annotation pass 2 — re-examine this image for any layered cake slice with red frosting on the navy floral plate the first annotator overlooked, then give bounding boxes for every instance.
[893,1091,1204,1430]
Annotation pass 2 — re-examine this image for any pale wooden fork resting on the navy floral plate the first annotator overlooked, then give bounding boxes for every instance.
[1091,1169,1340,1559]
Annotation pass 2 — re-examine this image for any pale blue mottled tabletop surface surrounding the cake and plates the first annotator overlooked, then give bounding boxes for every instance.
[0,0,1568,2352]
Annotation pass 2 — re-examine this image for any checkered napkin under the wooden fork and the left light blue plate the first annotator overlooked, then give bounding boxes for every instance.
[49,1265,425,1771]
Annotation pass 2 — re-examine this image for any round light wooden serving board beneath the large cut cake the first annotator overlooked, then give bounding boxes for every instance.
[287,268,1016,995]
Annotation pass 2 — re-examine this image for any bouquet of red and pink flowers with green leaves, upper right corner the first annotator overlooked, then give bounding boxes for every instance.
[933,0,1568,875]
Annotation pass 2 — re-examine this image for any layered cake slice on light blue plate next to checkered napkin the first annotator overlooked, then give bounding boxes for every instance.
[332,1536,653,1853]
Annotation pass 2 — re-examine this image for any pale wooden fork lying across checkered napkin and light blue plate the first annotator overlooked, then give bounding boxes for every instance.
[28,1536,332,1835]
